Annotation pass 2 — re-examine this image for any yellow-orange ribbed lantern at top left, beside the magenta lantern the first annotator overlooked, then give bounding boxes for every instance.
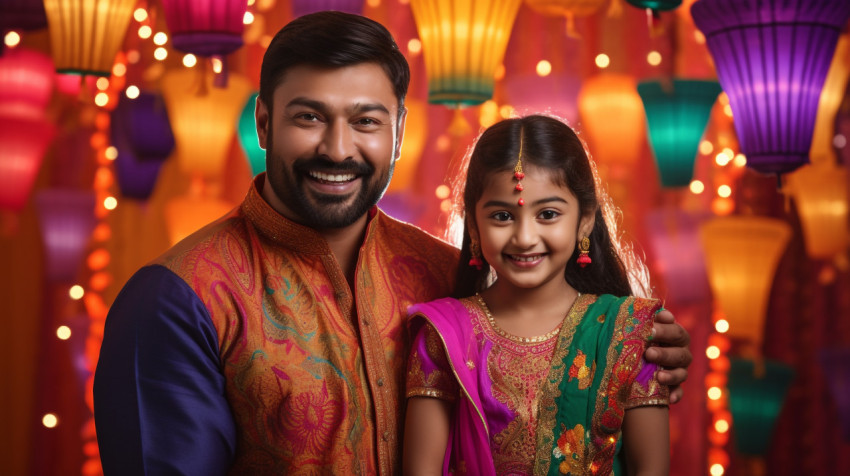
[44,0,138,76]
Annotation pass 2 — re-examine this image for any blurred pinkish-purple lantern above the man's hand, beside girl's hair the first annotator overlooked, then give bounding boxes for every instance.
[646,209,709,304]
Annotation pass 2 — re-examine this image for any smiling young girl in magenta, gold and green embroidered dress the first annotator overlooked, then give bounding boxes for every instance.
[404,116,669,476]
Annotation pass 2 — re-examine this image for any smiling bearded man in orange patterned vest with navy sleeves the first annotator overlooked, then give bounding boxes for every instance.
[94,12,690,475]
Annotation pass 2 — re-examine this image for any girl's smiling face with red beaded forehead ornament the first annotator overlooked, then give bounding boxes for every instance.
[470,165,593,289]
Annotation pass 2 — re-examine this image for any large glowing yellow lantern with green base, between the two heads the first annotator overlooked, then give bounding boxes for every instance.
[410,0,521,107]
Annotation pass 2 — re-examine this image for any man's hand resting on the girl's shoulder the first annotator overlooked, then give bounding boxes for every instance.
[644,310,693,403]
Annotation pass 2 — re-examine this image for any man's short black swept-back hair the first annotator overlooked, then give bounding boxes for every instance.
[260,11,410,114]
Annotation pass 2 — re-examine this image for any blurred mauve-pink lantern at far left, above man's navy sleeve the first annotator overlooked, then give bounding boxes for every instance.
[35,189,97,282]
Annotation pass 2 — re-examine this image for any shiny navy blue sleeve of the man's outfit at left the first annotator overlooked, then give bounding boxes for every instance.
[94,266,236,476]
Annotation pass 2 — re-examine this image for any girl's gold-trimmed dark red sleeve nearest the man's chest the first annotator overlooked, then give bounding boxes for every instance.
[407,323,459,402]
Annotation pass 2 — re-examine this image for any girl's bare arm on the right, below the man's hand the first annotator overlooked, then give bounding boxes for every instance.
[623,406,670,476]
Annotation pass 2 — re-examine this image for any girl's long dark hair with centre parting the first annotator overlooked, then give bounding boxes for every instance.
[449,115,648,298]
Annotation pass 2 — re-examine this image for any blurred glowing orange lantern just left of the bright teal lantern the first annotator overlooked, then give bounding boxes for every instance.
[578,73,646,165]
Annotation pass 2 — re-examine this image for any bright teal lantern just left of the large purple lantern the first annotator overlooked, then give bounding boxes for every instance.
[637,79,721,187]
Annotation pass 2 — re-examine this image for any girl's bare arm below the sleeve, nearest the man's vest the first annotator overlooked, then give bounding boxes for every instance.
[402,397,452,475]
